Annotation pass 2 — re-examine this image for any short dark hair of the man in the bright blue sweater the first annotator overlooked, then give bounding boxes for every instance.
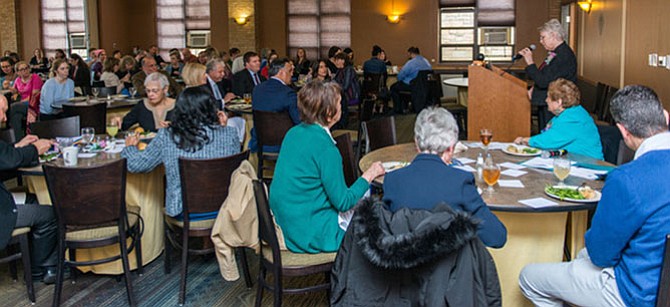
[610,85,668,139]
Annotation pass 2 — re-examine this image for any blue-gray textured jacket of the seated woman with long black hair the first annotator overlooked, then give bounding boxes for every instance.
[121,127,240,216]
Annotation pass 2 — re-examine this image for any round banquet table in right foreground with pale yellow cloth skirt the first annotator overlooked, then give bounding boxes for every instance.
[359,143,611,306]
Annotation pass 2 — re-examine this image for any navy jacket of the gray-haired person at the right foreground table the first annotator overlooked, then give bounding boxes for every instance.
[384,154,507,247]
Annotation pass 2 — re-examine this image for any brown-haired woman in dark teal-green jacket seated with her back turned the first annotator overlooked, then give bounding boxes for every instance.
[270,81,384,253]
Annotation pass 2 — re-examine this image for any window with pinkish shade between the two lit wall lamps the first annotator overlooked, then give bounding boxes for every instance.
[287,0,351,59]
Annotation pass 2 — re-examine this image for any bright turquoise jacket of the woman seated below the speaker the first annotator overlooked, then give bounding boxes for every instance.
[528,105,603,160]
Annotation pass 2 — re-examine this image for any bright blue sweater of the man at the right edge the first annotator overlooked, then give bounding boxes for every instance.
[585,150,670,306]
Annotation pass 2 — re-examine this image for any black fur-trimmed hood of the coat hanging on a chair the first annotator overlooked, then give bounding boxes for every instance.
[351,199,478,269]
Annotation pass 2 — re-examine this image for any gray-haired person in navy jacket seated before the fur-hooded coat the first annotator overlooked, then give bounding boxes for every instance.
[384,108,507,248]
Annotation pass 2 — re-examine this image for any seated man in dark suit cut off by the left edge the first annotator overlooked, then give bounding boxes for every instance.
[0,96,58,284]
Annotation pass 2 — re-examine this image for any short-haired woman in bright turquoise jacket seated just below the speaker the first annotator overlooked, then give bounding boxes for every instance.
[514,78,603,160]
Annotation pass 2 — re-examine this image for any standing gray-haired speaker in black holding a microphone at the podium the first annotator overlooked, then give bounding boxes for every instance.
[519,19,577,130]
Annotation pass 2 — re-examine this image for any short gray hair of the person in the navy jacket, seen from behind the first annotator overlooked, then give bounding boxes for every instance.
[414,107,458,154]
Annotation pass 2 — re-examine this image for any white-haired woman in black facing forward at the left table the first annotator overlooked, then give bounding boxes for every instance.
[114,72,175,132]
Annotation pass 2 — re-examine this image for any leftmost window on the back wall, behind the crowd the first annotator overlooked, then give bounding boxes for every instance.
[41,0,88,58]
